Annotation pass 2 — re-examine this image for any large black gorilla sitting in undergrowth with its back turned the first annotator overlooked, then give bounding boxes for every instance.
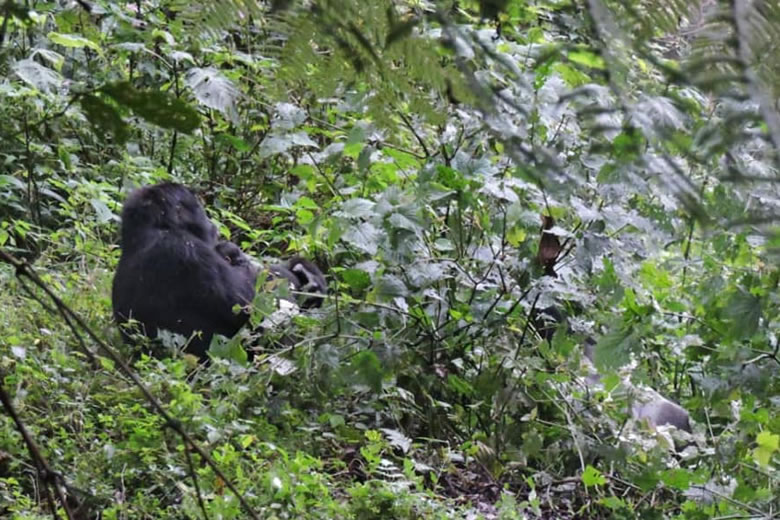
[112,183,327,359]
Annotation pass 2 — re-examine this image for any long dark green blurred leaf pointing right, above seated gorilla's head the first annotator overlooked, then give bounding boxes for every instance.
[101,82,200,134]
